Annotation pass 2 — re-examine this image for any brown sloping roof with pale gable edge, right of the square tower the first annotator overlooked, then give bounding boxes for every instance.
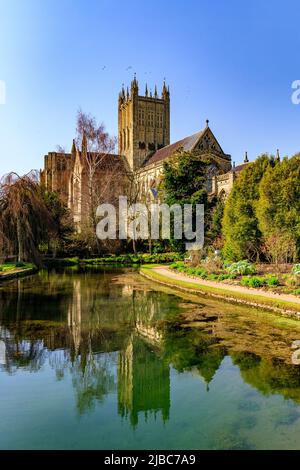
[144,126,230,167]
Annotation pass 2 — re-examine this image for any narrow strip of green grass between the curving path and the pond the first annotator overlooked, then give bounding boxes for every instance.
[141,265,300,312]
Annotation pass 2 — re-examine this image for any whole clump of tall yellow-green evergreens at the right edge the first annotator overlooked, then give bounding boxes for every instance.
[222,155,300,264]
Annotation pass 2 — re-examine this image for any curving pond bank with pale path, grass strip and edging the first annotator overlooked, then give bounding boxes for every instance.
[140,266,300,319]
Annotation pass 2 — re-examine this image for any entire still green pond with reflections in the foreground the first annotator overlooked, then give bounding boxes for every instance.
[0,268,300,449]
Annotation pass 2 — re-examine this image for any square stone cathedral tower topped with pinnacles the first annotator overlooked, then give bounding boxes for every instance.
[118,77,170,171]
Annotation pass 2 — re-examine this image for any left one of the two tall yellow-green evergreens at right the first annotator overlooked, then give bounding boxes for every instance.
[222,155,275,261]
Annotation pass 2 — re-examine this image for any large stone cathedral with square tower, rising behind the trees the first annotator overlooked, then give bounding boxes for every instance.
[41,77,248,226]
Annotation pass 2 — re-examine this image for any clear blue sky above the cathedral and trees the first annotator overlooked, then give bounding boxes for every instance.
[0,0,300,174]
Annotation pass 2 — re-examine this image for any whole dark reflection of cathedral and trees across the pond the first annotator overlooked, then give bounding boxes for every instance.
[0,271,300,427]
